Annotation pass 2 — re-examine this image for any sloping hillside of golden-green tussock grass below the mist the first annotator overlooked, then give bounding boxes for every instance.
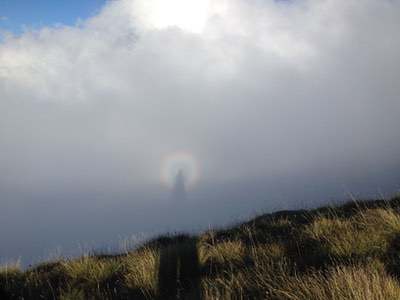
[0,197,400,300]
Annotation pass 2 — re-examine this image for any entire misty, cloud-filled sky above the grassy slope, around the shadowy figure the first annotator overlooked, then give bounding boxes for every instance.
[0,0,400,263]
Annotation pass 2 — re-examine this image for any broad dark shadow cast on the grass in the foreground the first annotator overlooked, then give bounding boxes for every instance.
[158,236,201,300]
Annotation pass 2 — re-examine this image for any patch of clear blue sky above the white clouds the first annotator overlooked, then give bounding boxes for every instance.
[0,0,106,34]
